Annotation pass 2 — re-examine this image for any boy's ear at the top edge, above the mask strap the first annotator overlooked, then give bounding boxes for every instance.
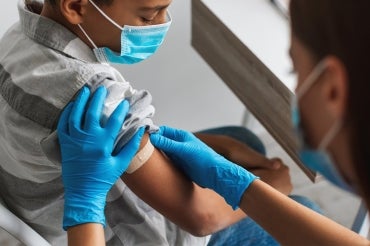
[59,0,88,25]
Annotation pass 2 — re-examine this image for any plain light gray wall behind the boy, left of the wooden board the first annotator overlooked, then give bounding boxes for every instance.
[0,0,243,133]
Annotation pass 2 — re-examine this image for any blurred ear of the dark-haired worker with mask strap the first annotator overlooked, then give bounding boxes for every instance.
[321,56,349,119]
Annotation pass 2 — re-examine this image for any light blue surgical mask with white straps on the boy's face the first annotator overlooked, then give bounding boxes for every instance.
[78,0,172,64]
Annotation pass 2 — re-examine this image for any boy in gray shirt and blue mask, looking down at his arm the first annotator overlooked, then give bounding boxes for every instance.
[0,0,291,245]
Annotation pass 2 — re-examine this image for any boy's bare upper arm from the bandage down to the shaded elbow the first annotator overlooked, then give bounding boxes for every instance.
[122,134,201,234]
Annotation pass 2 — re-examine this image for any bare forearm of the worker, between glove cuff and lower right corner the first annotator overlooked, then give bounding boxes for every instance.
[240,180,370,246]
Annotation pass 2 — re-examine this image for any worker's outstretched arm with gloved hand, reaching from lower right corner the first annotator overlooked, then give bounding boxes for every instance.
[151,127,369,245]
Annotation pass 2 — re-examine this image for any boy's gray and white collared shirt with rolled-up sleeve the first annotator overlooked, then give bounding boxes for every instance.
[0,0,206,245]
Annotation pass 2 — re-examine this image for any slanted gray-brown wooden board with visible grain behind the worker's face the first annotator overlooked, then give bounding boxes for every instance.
[192,0,316,181]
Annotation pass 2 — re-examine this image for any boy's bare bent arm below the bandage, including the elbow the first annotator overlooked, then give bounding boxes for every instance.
[122,135,246,236]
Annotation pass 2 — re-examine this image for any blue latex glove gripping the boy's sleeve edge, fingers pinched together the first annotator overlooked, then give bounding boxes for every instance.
[150,126,257,209]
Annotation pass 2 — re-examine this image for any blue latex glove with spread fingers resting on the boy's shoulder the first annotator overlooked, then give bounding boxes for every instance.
[58,87,144,230]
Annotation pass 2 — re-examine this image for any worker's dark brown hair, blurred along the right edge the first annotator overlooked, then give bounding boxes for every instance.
[290,0,370,207]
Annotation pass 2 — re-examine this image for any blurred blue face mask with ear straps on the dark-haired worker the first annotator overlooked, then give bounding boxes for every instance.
[291,61,354,192]
